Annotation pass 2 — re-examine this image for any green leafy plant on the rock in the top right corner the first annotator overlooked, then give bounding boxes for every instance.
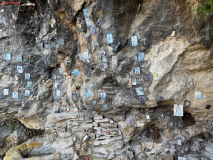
[197,0,213,15]
